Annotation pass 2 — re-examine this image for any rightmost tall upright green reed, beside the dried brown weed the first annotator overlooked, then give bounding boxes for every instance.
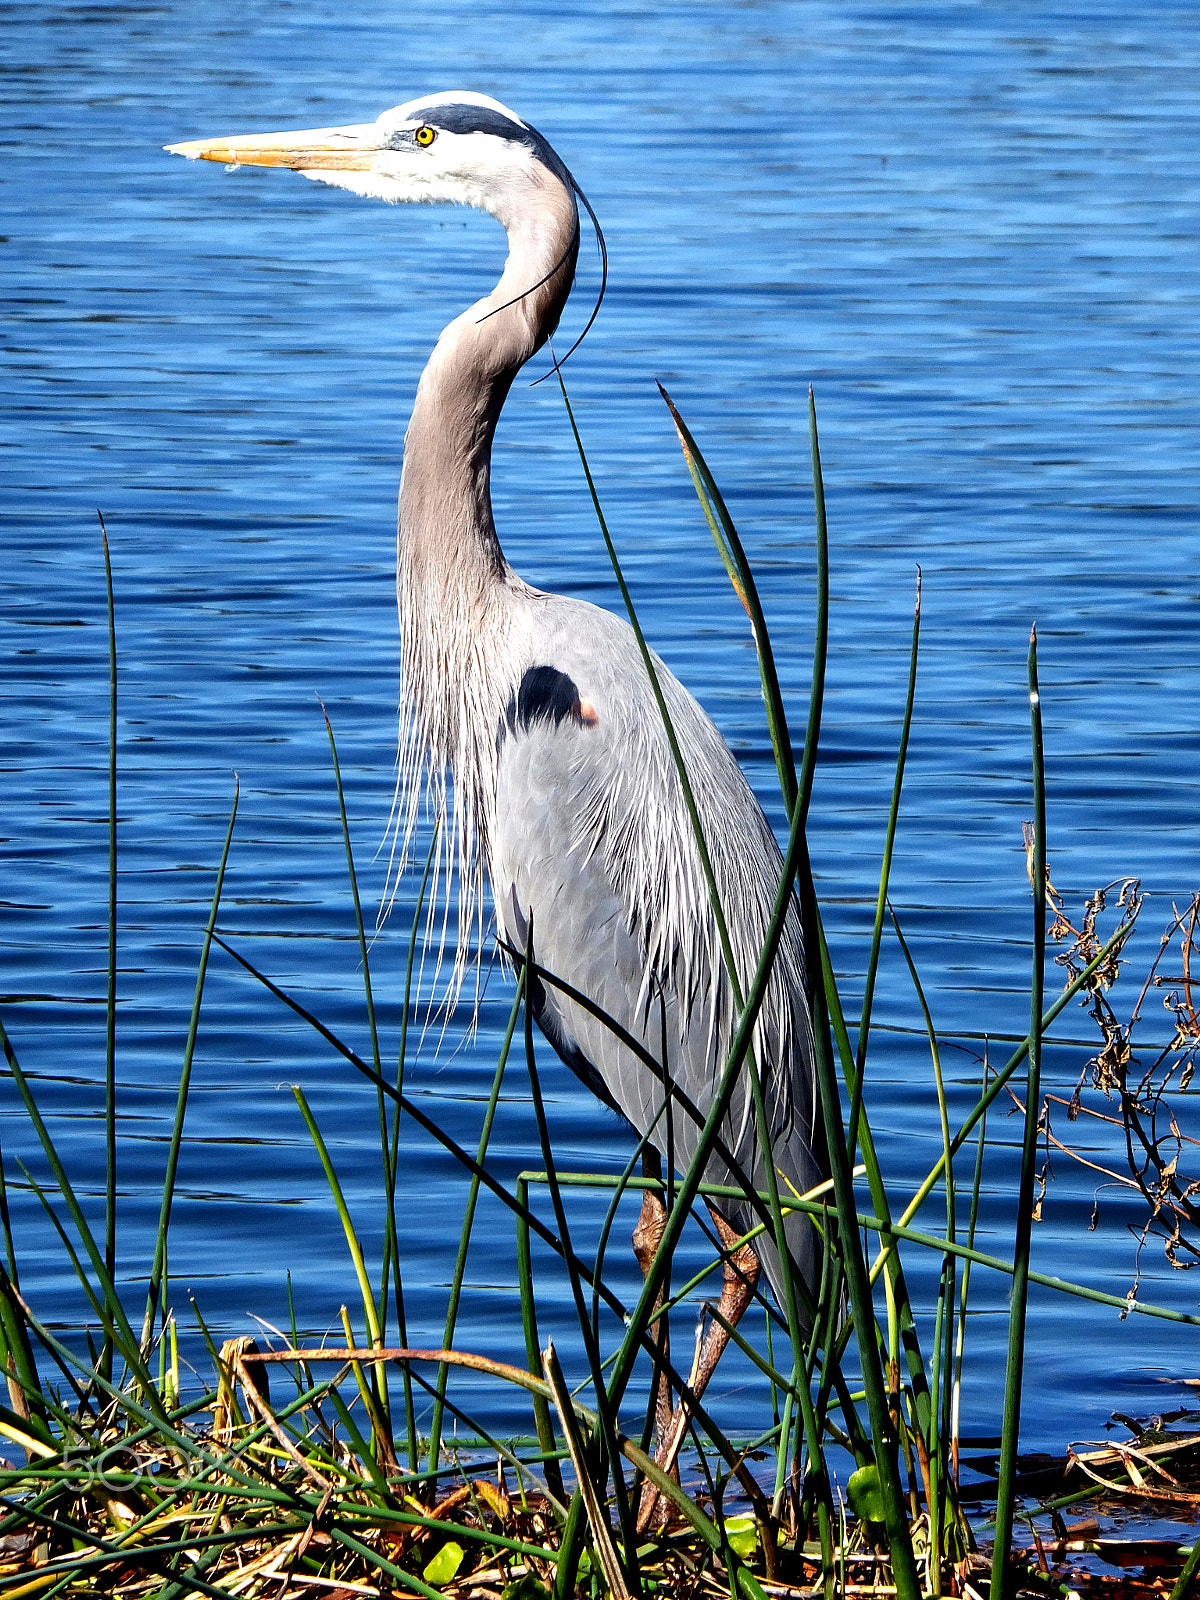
[990,627,1046,1600]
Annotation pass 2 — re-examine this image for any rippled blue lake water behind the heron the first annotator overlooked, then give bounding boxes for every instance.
[0,0,1200,1497]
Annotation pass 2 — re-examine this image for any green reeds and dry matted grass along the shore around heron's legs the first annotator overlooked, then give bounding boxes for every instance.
[0,390,1200,1600]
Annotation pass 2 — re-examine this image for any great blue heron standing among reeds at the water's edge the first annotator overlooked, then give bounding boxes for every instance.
[170,91,822,1518]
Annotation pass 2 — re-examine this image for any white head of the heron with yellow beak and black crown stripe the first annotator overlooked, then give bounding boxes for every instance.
[166,90,574,226]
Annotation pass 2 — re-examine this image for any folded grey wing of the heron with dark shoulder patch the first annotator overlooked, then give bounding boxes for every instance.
[490,597,819,1292]
